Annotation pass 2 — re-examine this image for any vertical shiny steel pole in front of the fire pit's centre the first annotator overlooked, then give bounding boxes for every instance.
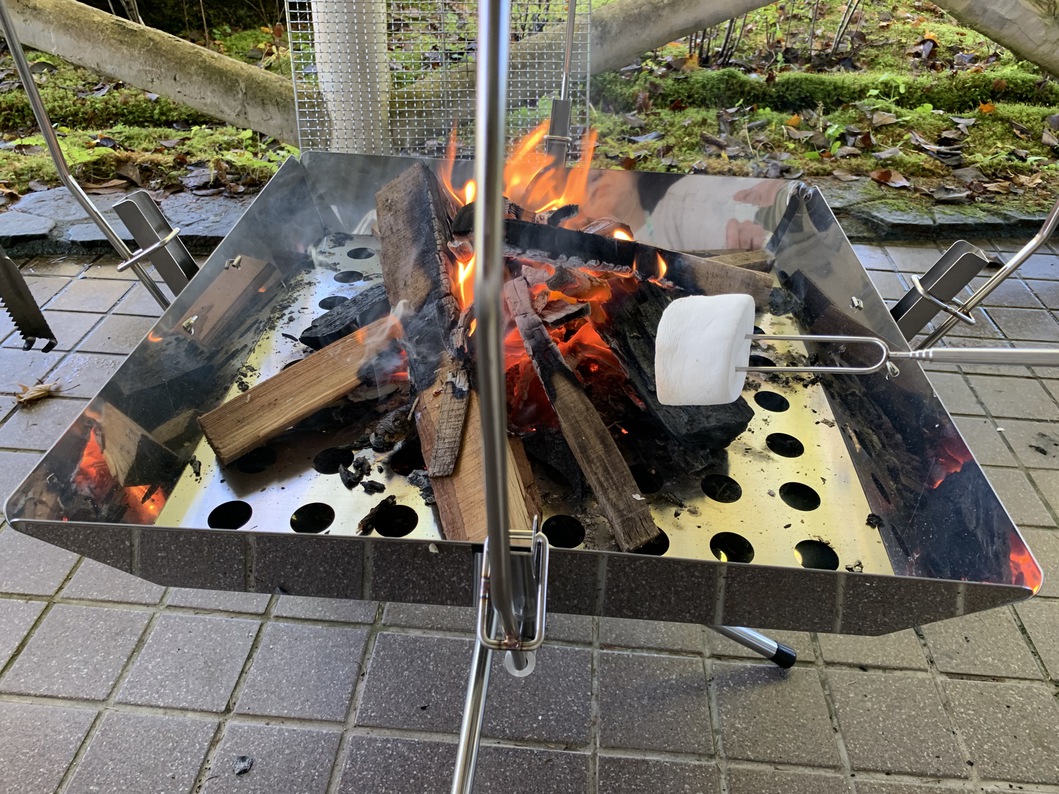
[474,0,525,669]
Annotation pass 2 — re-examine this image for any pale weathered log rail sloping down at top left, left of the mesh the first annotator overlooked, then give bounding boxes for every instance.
[6,0,298,143]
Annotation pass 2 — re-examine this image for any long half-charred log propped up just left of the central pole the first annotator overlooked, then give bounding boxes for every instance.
[376,164,539,541]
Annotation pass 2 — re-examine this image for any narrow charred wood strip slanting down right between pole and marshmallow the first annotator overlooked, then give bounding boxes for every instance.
[504,278,661,552]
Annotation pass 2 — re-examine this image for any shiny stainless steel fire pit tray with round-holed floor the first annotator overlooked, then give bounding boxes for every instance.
[6,152,1041,634]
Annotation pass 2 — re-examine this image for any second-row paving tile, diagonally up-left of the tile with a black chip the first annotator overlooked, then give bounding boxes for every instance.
[118,613,259,711]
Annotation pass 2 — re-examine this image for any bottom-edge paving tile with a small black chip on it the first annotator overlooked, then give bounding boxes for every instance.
[202,722,342,794]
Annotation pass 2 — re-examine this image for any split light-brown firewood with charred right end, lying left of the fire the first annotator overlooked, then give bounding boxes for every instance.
[199,317,401,464]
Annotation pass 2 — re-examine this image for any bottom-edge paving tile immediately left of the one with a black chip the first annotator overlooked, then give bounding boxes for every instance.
[67,711,217,794]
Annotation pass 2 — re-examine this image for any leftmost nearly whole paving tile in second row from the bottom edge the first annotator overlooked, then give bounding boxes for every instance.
[0,603,150,700]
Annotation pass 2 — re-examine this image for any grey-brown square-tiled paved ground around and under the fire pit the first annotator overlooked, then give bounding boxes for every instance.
[0,243,1059,794]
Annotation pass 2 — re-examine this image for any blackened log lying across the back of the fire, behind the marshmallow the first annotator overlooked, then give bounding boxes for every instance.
[504,220,772,309]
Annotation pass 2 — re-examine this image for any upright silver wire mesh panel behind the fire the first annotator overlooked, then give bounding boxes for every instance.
[287,0,589,159]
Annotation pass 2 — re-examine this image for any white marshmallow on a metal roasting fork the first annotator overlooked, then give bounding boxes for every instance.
[654,294,754,405]
